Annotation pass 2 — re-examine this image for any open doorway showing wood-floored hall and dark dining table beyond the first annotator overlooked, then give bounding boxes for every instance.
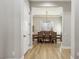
[25,1,71,59]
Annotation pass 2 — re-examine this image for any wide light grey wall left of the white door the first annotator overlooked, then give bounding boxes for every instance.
[0,0,28,59]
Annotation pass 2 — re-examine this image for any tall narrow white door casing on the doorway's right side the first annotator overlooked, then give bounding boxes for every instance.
[71,0,75,59]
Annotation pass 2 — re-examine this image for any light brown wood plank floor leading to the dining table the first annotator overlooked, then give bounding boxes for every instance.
[24,44,70,59]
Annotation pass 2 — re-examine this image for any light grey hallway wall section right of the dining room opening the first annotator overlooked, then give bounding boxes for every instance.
[62,11,71,48]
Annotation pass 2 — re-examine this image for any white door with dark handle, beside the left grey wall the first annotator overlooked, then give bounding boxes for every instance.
[22,3,31,54]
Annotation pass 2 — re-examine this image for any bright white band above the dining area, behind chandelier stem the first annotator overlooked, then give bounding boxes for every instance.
[31,7,63,16]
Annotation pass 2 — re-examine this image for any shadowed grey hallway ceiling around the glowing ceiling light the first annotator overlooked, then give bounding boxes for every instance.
[30,1,71,11]
